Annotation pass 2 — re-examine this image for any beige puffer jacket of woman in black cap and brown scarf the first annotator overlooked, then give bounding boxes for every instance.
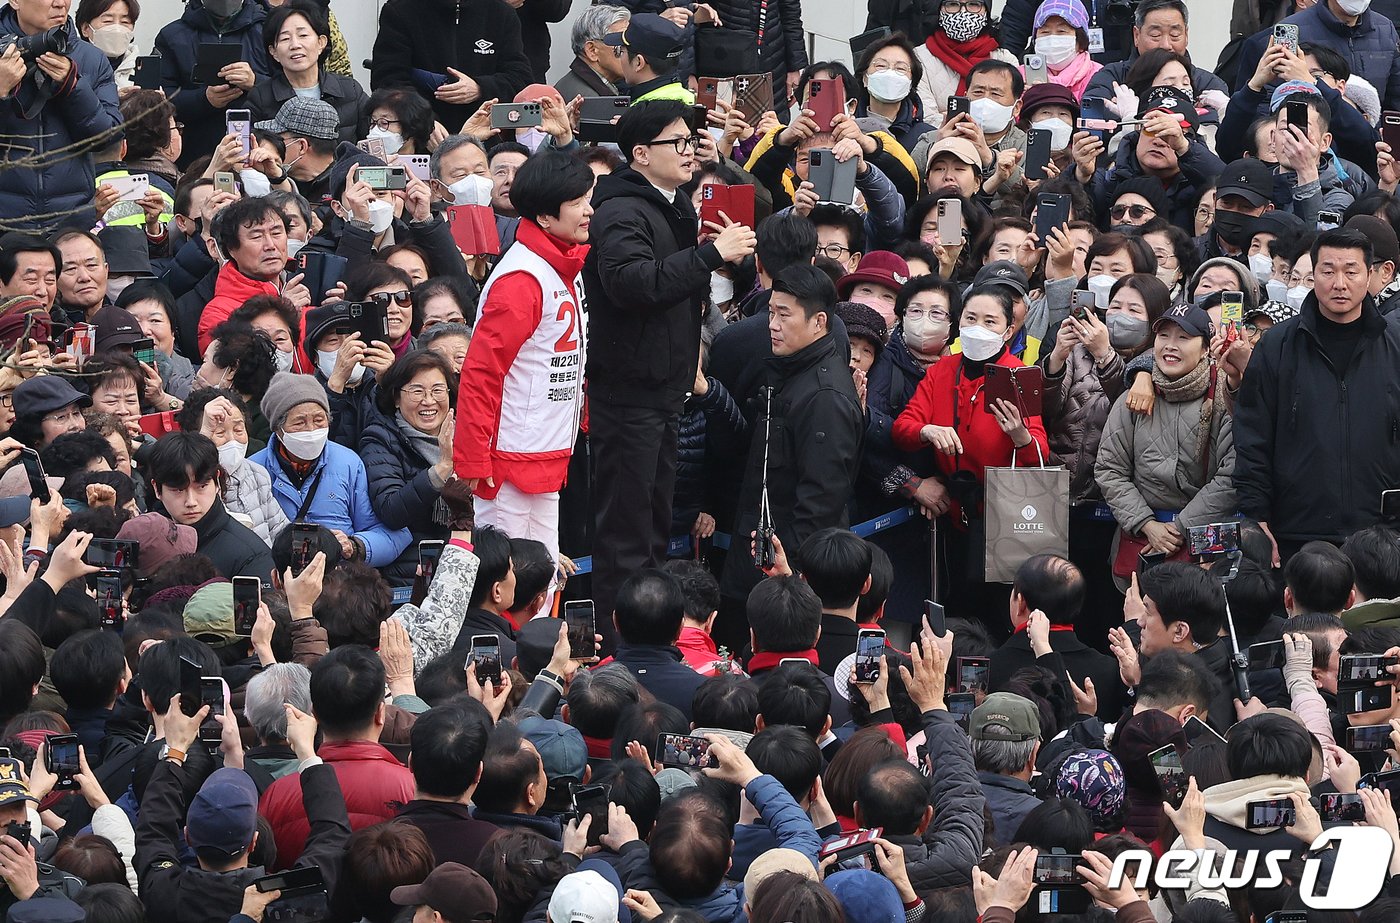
[1096,372,1235,535]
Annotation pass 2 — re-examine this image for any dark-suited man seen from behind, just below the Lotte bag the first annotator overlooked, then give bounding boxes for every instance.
[988,555,1126,721]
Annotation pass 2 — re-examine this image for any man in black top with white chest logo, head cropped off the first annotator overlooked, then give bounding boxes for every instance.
[370,0,532,132]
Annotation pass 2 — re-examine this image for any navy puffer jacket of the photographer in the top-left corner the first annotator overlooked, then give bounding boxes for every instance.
[0,4,122,231]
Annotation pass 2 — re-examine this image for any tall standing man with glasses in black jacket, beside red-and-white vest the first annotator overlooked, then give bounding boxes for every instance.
[579,97,755,634]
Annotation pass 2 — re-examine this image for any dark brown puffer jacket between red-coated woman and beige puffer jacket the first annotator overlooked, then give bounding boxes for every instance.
[1040,346,1123,503]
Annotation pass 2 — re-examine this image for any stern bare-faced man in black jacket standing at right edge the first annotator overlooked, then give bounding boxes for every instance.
[1235,228,1400,559]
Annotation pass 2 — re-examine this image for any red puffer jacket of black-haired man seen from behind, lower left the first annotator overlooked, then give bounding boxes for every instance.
[258,741,413,870]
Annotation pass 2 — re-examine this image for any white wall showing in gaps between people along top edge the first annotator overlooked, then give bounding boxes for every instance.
[128,0,1229,99]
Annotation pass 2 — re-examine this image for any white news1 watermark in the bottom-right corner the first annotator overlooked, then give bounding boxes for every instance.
[1109,826,1394,910]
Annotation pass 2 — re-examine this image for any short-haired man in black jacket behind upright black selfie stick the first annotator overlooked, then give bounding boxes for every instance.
[721,265,865,607]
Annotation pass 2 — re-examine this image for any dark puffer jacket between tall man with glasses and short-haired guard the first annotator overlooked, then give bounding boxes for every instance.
[671,378,749,535]
